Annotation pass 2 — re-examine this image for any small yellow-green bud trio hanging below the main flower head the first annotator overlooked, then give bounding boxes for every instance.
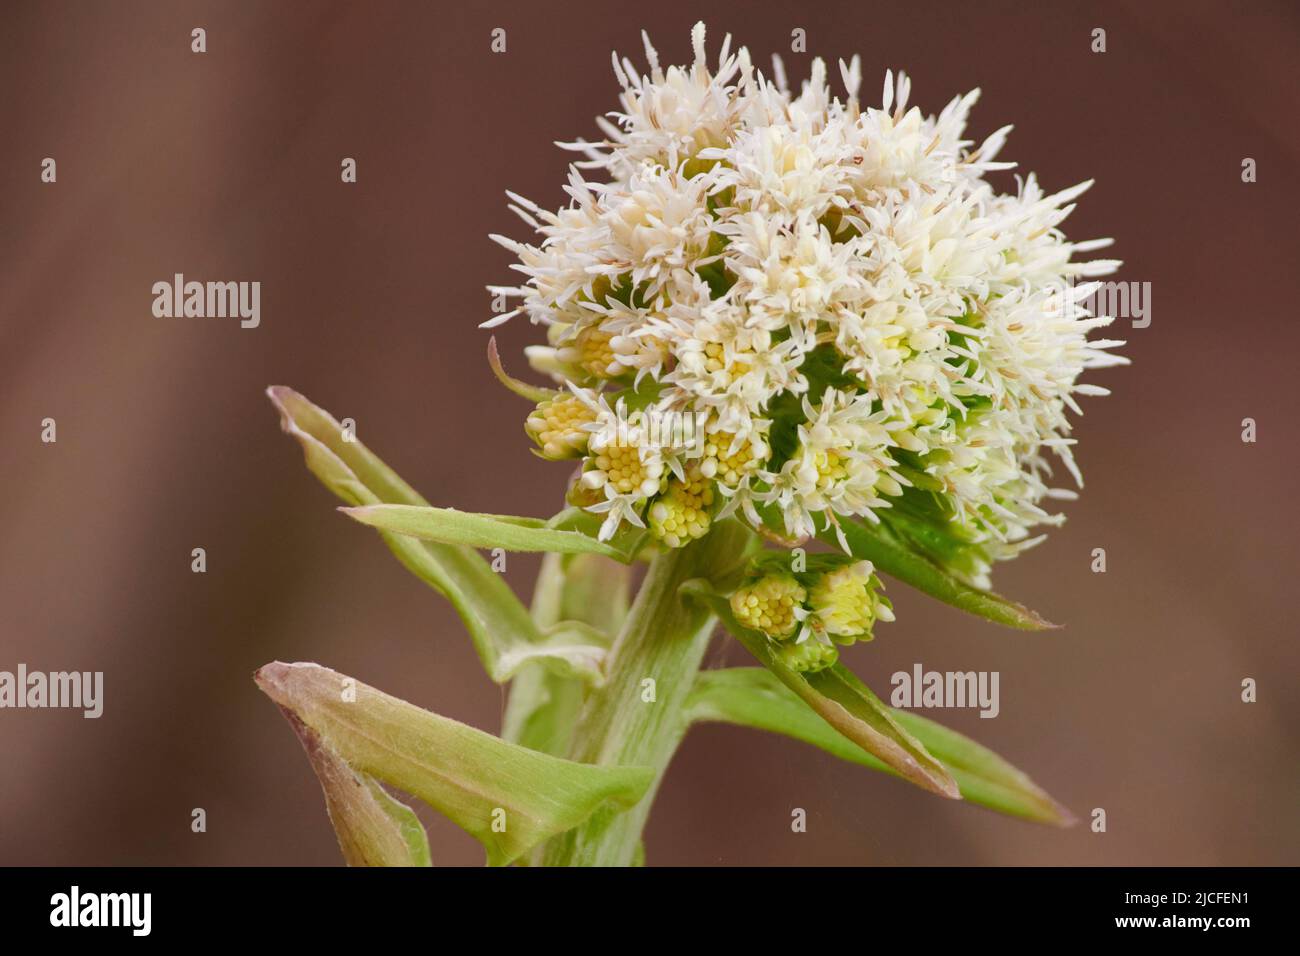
[731,555,894,671]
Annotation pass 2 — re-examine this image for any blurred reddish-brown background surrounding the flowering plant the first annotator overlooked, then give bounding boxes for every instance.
[0,0,1300,865]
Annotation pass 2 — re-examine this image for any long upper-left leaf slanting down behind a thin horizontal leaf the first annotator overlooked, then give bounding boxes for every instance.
[267,385,572,682]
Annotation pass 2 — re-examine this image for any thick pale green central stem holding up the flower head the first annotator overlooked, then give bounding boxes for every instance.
[545,522,751,866]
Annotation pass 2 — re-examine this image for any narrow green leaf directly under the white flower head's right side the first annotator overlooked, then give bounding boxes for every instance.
[818,518,1058,631]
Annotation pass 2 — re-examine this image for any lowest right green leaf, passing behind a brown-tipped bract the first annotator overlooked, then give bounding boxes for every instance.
[689,667,1076,826]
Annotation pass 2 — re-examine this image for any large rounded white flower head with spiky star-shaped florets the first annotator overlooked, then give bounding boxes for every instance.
[485,25,1123,579]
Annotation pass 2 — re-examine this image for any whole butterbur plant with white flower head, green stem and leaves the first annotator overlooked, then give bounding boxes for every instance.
[257,25,1123,866]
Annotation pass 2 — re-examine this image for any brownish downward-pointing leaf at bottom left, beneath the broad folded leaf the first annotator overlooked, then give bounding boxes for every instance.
[281,708,433,866]
